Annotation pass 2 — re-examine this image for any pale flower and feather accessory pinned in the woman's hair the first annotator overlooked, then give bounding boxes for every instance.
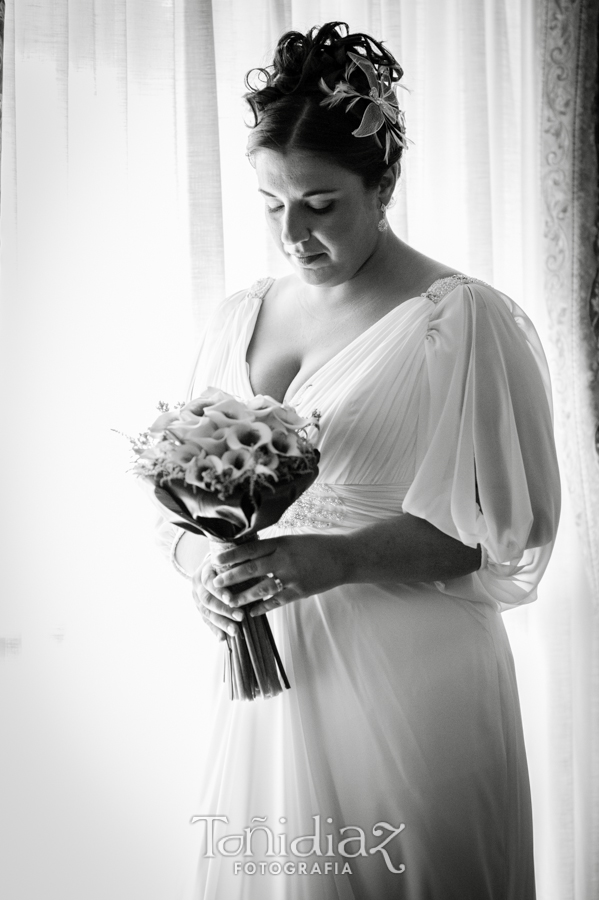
[319,52,407,162]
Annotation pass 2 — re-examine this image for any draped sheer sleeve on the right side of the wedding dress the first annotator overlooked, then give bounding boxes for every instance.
[403,283,560,610]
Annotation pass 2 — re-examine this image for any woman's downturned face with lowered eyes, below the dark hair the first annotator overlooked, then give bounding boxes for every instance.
[254,149,381,286]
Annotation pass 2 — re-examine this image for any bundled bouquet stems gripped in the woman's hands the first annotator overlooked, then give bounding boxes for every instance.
[209,535,290,700]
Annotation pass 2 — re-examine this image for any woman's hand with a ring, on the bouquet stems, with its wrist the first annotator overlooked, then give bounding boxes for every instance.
[204,534,344,616]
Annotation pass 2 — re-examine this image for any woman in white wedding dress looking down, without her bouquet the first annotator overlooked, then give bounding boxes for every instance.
[162,23,559,900]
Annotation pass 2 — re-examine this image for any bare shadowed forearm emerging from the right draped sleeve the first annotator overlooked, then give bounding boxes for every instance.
[330,513,481,584]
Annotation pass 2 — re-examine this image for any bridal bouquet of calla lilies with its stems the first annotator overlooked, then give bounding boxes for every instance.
[124,388,319,700]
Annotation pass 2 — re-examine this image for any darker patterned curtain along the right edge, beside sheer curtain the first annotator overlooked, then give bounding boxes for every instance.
[542,0,599,603]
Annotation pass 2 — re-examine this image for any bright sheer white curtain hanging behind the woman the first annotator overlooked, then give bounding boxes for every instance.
[0,0,597,900]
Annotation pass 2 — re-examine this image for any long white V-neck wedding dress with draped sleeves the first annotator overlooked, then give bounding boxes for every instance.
[164,276,559,900]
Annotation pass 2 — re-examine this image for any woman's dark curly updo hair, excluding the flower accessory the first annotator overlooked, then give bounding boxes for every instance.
[244,22,403,188]
